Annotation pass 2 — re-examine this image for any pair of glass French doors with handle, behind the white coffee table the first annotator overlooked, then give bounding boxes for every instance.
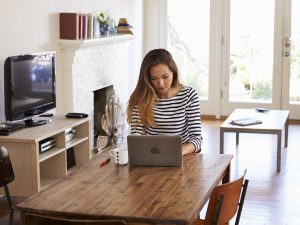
[221,0,300,119]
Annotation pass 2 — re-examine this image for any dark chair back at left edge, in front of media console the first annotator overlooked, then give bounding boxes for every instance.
[0,146,15,187]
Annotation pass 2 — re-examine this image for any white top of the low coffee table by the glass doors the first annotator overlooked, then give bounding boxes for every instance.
[220,109,289,131]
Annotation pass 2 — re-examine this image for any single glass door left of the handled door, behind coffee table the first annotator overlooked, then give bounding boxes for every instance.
[221,0,281,115]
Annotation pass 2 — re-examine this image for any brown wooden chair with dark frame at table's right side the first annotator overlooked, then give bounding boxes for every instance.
[194,170,249,225]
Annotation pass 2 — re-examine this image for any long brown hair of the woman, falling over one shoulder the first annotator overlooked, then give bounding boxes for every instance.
[127,49,180,125]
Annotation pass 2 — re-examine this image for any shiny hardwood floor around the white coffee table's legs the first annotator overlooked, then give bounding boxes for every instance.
[201,120,300,225]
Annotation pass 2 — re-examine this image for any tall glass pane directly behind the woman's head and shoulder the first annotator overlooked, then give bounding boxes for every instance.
[167,0,215,114]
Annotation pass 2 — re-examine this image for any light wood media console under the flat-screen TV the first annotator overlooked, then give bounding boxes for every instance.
[0,116,92,196]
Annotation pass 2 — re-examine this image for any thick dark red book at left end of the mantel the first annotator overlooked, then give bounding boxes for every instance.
[59,12,79,40]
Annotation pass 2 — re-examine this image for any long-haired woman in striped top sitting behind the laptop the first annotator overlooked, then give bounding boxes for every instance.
[127,49,202,155]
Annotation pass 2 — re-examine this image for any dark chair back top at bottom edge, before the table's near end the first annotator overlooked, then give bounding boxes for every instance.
[25,213,126,225]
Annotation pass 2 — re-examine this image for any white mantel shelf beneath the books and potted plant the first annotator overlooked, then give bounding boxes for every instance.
[58,34,134,49]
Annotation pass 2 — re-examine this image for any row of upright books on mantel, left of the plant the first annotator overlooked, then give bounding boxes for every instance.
[59,12,100,40]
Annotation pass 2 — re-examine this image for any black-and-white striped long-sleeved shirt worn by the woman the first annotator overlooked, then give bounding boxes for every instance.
[130,86,202,152]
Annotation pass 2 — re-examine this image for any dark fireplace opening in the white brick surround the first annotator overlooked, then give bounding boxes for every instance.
[93,85,114,152]
